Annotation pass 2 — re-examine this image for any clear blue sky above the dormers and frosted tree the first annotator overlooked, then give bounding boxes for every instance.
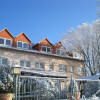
[0,0,97,43]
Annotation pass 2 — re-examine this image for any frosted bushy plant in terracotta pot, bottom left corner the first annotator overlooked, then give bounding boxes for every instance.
[0,66,14,100]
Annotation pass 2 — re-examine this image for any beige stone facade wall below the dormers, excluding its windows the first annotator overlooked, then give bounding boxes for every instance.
[0,47,84,78]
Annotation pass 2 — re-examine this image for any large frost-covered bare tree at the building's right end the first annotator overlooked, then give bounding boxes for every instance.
[62,20,100,75]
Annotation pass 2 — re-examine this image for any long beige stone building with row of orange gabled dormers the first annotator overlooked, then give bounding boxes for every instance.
[0,29,85,78]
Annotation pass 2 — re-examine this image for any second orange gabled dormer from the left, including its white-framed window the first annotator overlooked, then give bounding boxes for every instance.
[15,33,31,49]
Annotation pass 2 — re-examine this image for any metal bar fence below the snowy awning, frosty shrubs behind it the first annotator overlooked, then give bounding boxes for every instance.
[17,76,67,100]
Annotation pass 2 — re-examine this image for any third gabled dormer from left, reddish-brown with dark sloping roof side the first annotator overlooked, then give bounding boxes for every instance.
[33,38,54,53]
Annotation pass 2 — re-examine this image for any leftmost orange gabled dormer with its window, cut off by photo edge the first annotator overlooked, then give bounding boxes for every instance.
[0,29,14,47]
